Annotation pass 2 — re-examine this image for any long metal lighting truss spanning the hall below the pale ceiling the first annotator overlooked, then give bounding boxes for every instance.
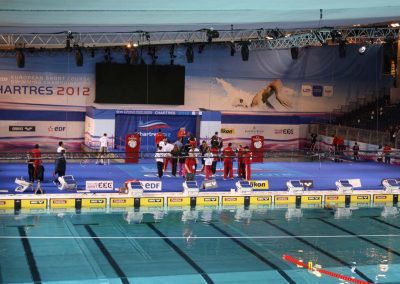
[0,27,399,51]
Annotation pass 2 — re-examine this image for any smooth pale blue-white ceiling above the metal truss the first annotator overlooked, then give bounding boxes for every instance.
[0,0,400,33]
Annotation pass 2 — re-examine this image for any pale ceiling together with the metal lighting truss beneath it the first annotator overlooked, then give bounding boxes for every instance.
[0,0,400,50]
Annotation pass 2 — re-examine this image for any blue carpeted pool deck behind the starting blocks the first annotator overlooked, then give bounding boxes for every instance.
[0,162,400,193]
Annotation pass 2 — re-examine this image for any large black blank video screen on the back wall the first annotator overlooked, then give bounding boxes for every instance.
[95,63,185,105]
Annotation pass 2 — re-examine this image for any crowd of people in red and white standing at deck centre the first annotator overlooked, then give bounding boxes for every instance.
[155,128,252,180]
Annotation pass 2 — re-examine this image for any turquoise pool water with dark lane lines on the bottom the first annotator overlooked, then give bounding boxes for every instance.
[0,207,400,284]
